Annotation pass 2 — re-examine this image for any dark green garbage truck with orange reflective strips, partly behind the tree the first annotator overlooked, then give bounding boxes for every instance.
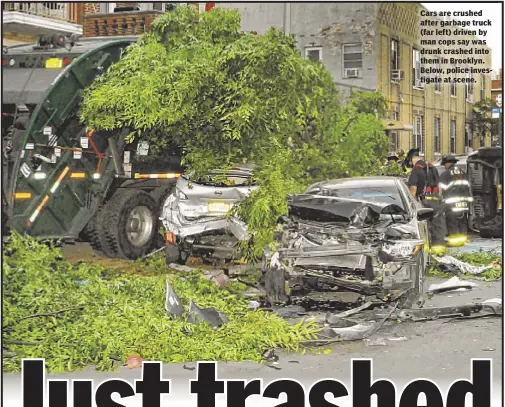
[2,35,183,259]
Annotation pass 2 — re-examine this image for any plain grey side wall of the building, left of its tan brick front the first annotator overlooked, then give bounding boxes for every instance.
[216,3,378,95]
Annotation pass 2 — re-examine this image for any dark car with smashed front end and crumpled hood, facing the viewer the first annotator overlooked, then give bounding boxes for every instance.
[263,177,433,309]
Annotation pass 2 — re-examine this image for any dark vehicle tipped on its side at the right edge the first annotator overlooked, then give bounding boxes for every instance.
[466,147,503,238]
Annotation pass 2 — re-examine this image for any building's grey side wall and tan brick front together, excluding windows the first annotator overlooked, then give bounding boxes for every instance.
[217,3,491,160]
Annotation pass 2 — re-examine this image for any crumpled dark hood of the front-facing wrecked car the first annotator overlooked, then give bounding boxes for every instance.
[288,194,406,227]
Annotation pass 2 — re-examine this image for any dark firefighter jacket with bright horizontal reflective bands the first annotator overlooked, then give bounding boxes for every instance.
[439,165,473,212]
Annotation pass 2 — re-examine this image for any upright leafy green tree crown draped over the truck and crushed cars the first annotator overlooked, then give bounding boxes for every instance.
[82,7,389,258]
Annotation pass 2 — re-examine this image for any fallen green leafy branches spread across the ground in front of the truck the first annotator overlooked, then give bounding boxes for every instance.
[2,235,317,372]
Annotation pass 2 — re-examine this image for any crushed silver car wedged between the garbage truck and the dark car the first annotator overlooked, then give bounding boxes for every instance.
[160,165,257,263]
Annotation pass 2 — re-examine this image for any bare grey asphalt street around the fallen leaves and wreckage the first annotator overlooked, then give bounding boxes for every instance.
[3,239,503,406]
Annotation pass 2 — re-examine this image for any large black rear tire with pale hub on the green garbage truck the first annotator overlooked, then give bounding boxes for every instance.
[103,188,158,260]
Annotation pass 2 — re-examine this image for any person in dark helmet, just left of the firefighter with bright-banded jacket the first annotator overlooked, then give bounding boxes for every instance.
[406,149,446,256]
